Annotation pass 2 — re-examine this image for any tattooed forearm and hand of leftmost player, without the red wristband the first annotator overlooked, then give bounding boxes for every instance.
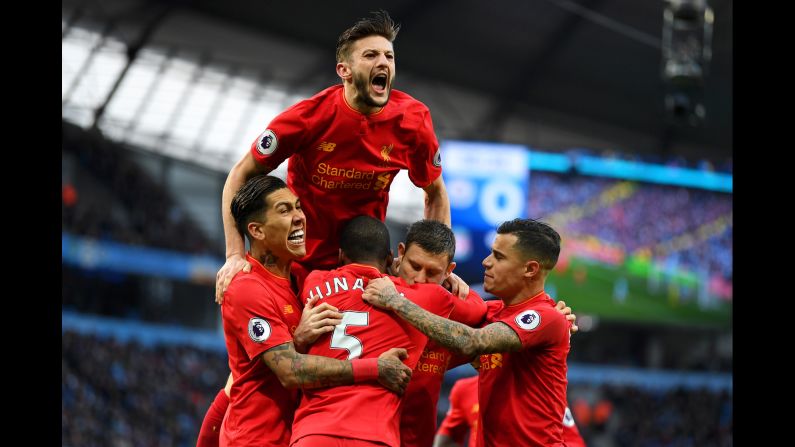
[262,342,411,394]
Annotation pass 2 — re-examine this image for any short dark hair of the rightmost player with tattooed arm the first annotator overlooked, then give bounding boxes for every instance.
[497,219,560,270]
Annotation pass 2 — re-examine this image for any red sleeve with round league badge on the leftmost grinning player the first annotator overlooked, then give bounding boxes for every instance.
[224,276,293,359]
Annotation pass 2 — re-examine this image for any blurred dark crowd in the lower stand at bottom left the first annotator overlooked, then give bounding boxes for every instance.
[61,331,224,447]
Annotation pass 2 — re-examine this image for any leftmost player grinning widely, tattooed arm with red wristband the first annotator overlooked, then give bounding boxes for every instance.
[220,175,411,446]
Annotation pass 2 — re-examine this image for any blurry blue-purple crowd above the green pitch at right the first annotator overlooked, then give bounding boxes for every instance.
[529,172,732,281]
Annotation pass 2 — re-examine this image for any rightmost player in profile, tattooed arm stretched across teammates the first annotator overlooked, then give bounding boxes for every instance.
[362,219,571,446]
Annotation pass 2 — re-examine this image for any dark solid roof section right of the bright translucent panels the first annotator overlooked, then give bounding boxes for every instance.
[182,0,732,152]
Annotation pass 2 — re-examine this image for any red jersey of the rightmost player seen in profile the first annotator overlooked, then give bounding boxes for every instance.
[478,291,571,446]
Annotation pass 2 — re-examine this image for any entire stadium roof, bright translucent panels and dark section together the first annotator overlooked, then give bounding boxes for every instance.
[62,0,732,170]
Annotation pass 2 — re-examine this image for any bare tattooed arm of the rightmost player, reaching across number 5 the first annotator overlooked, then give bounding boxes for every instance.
[362,278,522,357]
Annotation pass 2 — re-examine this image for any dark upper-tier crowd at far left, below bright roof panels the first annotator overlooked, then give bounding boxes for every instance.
[61,124,220,255]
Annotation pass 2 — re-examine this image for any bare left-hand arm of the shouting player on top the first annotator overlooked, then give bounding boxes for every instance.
[215,152,270,304]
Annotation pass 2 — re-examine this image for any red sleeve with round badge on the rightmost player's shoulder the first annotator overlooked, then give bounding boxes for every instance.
[497,306,571,348]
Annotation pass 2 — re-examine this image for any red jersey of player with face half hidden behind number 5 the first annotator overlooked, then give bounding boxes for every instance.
[400,289,488,447]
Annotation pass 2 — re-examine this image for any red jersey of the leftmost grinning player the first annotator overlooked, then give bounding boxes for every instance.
[219,255,302,446]
